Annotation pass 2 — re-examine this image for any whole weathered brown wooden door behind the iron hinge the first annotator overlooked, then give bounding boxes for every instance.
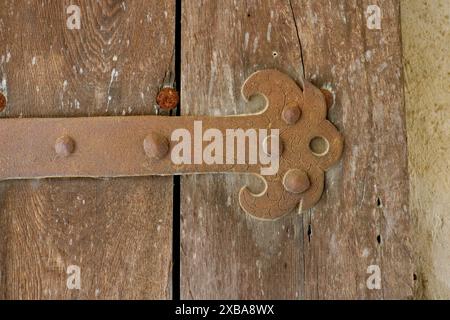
[0,0,414,299]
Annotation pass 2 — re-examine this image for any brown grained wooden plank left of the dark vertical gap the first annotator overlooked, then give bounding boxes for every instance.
[0,0,175,299]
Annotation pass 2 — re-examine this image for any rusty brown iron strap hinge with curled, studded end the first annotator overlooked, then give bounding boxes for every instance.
[0,70,343,219]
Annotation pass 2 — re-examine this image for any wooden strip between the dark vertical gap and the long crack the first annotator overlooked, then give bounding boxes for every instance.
[181,1,304,299]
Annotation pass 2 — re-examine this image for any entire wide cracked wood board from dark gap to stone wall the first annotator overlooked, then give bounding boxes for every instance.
[181,0,413,299]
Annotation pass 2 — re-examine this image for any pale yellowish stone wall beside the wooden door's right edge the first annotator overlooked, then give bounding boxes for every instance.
[401,0,450,299]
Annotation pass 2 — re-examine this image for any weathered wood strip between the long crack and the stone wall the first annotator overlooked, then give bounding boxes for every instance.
[293,0,413,299]
